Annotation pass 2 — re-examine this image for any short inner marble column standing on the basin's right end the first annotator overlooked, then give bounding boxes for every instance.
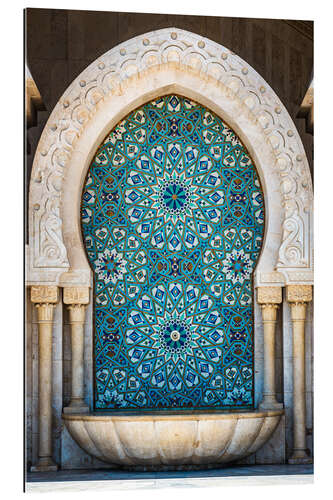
[257,286,283,410]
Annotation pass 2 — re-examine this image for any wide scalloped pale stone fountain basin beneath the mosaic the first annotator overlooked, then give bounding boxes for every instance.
[62,410,283,467]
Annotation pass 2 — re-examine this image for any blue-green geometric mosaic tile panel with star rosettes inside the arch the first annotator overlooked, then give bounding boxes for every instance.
[81,95,264,410]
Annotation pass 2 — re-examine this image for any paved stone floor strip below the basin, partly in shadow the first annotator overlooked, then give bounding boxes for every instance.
[26,465,313,493]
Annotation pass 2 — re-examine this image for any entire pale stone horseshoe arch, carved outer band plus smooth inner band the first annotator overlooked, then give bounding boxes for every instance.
[27,28,313,286]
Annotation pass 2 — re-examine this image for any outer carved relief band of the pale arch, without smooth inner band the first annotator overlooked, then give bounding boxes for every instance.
[29,28,312,284]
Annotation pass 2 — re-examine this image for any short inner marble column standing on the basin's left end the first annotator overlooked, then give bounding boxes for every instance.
[63,287,89,414]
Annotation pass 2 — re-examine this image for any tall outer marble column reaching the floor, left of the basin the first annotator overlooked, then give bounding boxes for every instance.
[31,285,58,472]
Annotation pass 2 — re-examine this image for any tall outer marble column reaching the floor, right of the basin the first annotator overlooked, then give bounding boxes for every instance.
[287,285,312,464]
